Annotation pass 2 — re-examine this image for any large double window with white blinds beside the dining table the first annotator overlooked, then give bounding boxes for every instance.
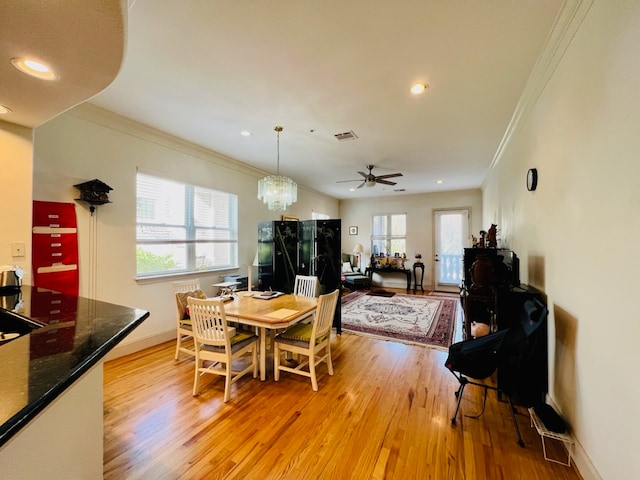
[136,173,238,277]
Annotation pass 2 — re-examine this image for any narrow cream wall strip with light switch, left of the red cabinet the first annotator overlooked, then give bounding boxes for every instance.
[0,121,33,284]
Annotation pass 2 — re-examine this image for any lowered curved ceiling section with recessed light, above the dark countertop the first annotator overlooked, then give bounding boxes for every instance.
[0,0,126,128]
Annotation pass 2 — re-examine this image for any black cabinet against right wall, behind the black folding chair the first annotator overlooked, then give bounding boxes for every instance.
[460,248,548,405]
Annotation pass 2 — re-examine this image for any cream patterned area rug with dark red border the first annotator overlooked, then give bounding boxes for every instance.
[342,292,459,349]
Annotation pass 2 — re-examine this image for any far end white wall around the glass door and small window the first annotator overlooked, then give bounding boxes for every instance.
[340,189,480,289]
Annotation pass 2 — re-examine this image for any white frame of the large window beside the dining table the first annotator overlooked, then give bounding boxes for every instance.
[136,171,239,280]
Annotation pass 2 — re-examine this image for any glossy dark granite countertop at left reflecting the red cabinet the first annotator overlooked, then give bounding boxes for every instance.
[0,286,149,446]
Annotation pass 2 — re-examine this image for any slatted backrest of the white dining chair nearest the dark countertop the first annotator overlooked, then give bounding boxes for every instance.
[187,297,231,350]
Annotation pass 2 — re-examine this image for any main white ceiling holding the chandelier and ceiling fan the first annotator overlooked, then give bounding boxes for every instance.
[0,0,563,198]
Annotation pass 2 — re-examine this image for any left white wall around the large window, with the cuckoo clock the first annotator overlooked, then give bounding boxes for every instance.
[33,104,338,352]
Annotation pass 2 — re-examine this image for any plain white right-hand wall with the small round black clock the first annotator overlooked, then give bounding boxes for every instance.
[483,0,640,479]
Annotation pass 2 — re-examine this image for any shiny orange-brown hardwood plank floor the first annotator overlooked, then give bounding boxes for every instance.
[104,290,580,480]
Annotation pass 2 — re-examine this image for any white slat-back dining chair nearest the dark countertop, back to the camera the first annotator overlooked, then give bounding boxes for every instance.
[187,297,258,402]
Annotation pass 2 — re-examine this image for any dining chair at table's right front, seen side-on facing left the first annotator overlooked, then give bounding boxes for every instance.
[273,290,340,392]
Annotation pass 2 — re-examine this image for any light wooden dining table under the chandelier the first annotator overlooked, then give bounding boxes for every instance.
[224,292,318,381]
